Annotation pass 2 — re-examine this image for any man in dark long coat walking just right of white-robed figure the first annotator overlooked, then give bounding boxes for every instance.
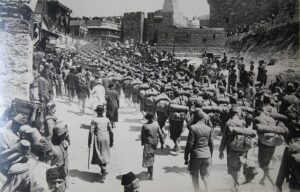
[105,84,120,127]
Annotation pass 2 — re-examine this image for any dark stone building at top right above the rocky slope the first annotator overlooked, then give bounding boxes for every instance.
[208,0,299,32]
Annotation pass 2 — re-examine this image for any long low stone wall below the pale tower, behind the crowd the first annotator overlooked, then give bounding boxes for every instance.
[157,27,225,52]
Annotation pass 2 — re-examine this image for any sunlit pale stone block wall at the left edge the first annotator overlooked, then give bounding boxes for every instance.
[0,18,33,110]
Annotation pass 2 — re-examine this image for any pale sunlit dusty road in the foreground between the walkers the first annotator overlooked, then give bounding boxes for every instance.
[57,92,290,192]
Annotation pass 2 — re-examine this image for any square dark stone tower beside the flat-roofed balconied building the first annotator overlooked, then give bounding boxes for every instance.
[122,12,145,44]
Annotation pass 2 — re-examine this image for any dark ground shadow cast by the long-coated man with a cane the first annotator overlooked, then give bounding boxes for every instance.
[70,169,104,183]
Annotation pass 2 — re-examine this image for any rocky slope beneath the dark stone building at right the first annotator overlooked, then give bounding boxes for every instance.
[226,22,300,82]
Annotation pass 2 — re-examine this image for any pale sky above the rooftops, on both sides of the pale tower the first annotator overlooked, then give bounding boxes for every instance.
[59,0,209,18]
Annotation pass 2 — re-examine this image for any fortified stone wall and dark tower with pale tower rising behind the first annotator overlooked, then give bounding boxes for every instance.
[142,0,225,53]
